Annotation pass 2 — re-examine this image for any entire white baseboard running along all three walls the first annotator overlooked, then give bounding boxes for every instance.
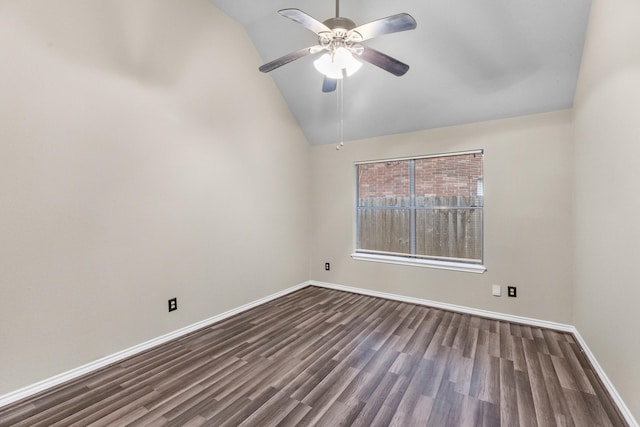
[0,280,639,427]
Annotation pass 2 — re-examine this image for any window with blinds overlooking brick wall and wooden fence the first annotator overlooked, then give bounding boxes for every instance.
[353,151,485,272]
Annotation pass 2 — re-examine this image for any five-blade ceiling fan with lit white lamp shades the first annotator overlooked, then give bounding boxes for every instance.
[259,0,417,92]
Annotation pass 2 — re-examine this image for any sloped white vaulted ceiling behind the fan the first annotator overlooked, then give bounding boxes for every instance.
[211,0,591,145]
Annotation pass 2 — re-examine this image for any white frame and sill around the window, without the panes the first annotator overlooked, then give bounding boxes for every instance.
[351,150,486,273]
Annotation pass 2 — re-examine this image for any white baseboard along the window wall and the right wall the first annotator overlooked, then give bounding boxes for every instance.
[308,280,639,427]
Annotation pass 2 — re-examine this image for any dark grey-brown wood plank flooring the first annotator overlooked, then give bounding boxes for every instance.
[0,286,627,427]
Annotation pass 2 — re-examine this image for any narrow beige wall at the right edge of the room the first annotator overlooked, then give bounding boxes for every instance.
[574,0,640,420]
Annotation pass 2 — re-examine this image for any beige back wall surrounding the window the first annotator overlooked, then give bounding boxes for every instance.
[311,111,573,323]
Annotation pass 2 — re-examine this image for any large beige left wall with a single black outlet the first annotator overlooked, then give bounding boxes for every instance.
[0,0,310,395]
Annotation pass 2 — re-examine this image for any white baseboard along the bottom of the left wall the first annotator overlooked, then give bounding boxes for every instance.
[0,282,309,408]
